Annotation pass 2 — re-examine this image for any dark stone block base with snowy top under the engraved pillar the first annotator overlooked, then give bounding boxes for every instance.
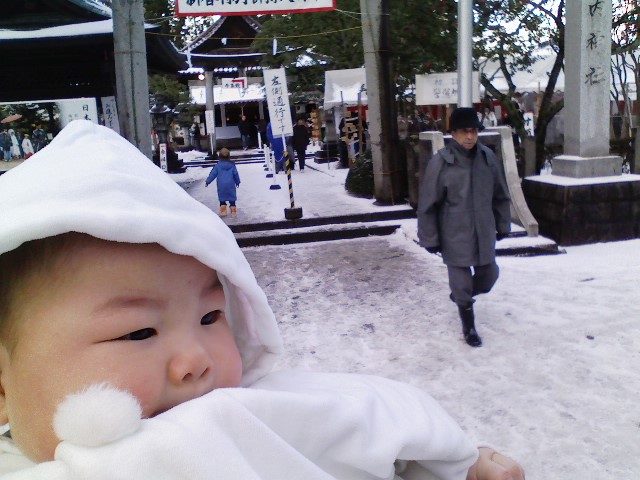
[522,174,640,246]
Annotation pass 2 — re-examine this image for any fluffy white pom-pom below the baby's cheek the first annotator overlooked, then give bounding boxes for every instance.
[53,383,142,447]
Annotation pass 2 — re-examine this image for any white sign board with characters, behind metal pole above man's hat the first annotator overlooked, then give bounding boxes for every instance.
[416,72,480,105]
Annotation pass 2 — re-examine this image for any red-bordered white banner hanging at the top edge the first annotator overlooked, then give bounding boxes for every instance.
[176,0,336,17]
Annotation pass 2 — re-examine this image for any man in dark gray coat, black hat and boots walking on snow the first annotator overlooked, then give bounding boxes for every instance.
[417,108,511,347]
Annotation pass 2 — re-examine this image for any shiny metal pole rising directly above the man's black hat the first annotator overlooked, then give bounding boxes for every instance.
[458,0,473,107]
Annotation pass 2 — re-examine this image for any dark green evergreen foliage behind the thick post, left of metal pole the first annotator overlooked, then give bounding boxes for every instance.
[253,0,457,106]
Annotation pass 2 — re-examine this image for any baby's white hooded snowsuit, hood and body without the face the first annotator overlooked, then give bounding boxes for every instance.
[0,120,477,480]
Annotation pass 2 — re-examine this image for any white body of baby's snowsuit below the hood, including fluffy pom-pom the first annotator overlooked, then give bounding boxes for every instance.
[1,372,477,480]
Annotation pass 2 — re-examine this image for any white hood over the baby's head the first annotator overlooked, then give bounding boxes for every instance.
[0,120,282,386]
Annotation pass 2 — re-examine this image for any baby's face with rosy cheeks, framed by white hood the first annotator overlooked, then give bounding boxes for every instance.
[0,241,242,462]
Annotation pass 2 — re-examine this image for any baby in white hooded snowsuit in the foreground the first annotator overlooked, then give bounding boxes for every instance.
[0,120,524,480]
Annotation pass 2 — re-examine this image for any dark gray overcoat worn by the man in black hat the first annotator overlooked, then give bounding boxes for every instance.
[417,140,511,267]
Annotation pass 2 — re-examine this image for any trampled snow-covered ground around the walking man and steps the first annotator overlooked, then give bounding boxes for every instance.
[172,152,640,480]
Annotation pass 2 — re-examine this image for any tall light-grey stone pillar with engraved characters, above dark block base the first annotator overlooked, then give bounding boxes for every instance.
[553,0,622,178]
